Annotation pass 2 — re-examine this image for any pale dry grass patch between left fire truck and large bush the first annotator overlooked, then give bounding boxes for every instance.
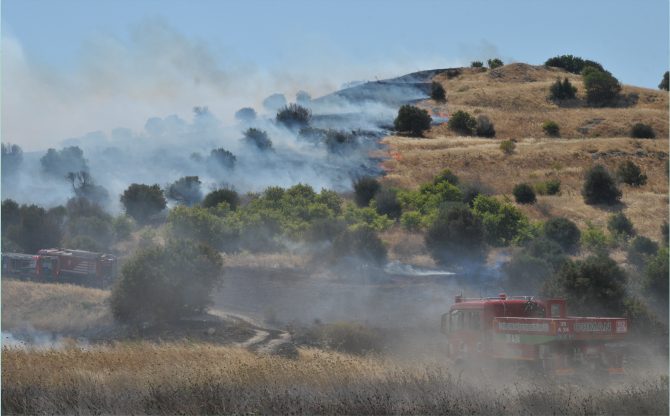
[2,279,113,333]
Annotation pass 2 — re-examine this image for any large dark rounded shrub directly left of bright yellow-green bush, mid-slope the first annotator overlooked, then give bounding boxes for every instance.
[424,204,484,263]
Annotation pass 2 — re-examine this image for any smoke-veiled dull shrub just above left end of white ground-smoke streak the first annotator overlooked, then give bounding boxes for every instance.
[332,225,388,264]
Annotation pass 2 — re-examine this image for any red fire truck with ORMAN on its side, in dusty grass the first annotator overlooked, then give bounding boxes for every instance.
[442,294,629,382]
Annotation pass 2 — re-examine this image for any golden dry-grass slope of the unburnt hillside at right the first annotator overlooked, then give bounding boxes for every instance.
[384,63,669,245]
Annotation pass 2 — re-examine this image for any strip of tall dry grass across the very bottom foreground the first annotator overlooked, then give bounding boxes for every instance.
[2,342,668,414]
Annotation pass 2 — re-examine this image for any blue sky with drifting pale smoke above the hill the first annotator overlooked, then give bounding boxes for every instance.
[2,0,670,151]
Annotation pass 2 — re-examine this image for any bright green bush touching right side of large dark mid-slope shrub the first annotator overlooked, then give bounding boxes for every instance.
[473,195,528,247]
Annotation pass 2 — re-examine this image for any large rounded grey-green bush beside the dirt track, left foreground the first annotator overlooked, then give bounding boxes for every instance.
[109,240,224,322]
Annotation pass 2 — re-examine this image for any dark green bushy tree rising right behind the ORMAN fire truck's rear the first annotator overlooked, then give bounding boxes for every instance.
[538,253,633,316]
